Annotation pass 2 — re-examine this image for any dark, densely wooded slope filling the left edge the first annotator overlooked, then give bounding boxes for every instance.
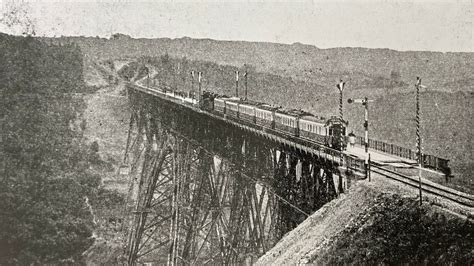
[0,34,100,265]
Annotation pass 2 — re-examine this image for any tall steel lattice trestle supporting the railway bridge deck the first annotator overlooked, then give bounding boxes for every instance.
[125,90,354,264]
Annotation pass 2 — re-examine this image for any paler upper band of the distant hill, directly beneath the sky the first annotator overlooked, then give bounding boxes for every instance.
[48,34,474,91]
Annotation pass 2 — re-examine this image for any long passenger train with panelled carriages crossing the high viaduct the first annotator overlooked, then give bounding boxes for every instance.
[135,82,348,150]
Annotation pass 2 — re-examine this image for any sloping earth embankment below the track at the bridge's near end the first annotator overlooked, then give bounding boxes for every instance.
[257,177,474,265]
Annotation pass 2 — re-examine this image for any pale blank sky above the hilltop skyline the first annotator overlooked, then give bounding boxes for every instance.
[0,0,474,52]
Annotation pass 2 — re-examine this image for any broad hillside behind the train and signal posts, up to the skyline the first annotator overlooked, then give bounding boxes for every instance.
[44,34,474,187]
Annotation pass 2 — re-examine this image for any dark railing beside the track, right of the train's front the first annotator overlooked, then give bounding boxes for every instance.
[356,136,451,175]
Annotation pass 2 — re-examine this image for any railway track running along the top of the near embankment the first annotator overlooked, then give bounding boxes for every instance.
[370,163,474,208]
